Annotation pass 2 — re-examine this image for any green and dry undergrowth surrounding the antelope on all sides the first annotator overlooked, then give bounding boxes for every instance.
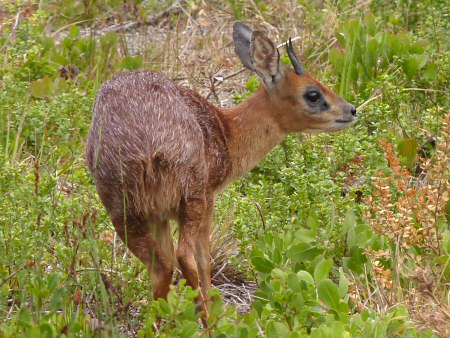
[0,0,450,337]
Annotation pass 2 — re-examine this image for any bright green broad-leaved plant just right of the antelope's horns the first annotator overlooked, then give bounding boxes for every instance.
[329,13,437,97]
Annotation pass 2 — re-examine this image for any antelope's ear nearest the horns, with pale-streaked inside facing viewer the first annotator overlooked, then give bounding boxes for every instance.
[250,31,281,85]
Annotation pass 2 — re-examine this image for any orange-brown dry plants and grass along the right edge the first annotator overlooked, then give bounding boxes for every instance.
[354,114,450,337]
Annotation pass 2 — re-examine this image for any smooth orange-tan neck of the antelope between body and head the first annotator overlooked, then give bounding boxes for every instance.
[222,86,287,179]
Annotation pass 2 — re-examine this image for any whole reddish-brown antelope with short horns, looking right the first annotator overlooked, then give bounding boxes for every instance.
[86,22,357,319]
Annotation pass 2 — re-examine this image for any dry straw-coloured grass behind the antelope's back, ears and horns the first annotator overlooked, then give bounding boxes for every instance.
[52,0,369,107]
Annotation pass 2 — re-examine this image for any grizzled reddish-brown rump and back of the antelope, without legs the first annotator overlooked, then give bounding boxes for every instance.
[87,71,231,218]
